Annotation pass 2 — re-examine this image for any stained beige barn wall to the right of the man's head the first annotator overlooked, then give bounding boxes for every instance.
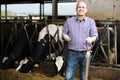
[84,0,120,20]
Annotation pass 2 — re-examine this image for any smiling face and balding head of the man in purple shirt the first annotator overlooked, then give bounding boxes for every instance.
[76,2,87,16]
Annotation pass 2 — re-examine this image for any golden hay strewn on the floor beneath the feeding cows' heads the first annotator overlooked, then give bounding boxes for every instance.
[0,69,102,80]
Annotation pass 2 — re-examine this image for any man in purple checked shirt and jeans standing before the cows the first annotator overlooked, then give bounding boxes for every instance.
[62,1,98,80]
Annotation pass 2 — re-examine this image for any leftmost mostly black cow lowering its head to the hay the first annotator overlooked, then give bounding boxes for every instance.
[1,24,42,69]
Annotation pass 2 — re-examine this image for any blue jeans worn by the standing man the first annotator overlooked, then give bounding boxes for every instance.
[65,51,90,80]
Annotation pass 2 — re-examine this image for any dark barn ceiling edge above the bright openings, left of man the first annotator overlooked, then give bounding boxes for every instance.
[0,0,76,4]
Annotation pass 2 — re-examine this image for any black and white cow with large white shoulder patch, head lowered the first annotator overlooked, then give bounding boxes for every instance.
[16,24,63,73]
